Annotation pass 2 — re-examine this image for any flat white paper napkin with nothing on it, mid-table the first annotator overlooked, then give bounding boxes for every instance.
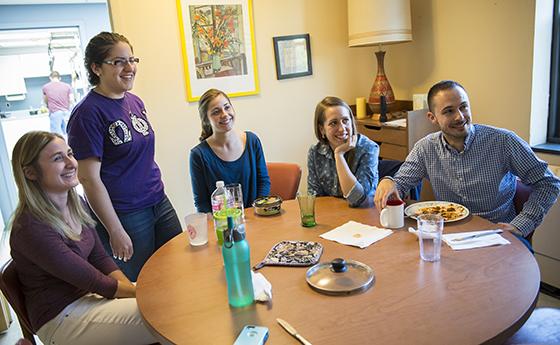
[319,220,393,249]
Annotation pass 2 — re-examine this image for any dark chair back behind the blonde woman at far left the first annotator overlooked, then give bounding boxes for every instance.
[0,259,36,345]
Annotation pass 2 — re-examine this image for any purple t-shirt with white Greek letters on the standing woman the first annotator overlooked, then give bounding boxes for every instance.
[68,91,165,212]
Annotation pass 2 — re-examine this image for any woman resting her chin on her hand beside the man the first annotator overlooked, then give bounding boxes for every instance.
[307,97,379,207]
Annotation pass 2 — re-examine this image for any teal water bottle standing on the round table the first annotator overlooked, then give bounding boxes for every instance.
[222,216,254,307]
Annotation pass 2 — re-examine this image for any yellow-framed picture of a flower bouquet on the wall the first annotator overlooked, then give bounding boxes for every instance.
[176,0,259,102]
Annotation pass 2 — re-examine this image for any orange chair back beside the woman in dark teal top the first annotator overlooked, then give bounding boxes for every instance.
[266,162,301,200]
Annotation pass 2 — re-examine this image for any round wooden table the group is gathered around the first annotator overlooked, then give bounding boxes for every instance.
[137,197,540,345]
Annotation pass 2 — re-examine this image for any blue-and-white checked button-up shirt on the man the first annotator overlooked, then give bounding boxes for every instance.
[394,125,560,236]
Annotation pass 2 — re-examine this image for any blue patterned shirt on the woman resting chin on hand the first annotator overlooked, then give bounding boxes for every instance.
[307,134,379,207]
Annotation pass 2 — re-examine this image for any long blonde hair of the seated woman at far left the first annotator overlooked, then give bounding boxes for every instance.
[10,131,95,241]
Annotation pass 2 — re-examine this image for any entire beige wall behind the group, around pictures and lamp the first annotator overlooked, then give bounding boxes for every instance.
[110,0,558,220]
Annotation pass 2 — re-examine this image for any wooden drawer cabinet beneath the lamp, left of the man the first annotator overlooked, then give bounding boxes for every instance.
[356,109,439,161]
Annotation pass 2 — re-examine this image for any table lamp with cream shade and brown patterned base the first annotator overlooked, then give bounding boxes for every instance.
[348,0,412,112]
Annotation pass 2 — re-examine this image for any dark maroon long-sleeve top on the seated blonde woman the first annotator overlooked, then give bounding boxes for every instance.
[10,213,118,332]
